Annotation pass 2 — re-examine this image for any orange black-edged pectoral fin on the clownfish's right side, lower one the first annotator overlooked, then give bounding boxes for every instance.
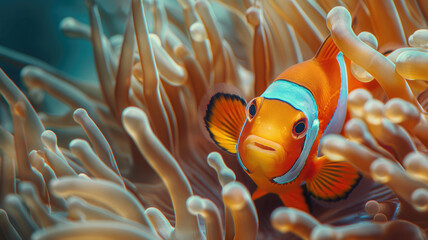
[306,156,361,201]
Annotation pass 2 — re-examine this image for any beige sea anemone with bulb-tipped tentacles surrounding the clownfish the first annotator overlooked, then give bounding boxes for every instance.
[0,0,428,240]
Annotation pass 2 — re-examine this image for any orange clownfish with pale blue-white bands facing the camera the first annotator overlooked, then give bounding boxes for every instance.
[203,37,378,212]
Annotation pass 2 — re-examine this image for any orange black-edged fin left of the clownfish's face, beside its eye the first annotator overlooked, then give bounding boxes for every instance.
[204,93,246,153]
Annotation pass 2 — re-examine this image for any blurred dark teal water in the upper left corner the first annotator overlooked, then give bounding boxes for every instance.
[0,0,96,83]
